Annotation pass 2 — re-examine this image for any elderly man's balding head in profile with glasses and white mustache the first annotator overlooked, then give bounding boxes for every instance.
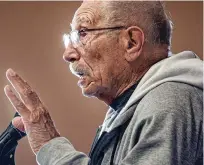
[64,1,171,104]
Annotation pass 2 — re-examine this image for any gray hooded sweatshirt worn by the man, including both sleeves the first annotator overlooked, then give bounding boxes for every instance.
[37,51,203,165]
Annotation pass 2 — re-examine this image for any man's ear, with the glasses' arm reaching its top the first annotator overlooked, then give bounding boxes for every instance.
[125,26,144,62]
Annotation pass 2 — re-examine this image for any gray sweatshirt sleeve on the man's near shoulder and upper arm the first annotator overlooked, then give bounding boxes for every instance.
[119,83,203,165]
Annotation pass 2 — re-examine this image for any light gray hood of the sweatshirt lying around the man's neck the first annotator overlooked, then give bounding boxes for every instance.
[101,51,203,132]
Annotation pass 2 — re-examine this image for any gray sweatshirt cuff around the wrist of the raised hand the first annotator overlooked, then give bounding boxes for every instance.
[36,137,89,165]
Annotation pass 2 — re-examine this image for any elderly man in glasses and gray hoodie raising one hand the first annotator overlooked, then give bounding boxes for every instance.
[5,1,203,165]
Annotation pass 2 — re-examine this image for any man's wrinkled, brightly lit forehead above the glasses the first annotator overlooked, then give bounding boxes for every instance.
[71,1,103,30]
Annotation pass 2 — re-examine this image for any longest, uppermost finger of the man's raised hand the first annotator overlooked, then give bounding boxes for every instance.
[6,69,40,110]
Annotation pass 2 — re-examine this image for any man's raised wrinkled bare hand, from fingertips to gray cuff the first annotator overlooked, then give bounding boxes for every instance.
[4,69,60,154]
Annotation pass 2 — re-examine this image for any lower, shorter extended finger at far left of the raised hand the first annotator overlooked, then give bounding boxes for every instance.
[4,85,30,118]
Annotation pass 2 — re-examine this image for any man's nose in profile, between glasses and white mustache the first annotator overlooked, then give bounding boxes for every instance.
[63,46,80,63]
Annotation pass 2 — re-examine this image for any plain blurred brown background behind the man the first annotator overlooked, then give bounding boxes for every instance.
[0,1,203,165]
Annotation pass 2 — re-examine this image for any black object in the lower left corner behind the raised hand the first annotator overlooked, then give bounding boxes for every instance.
[0,112,26,165]
